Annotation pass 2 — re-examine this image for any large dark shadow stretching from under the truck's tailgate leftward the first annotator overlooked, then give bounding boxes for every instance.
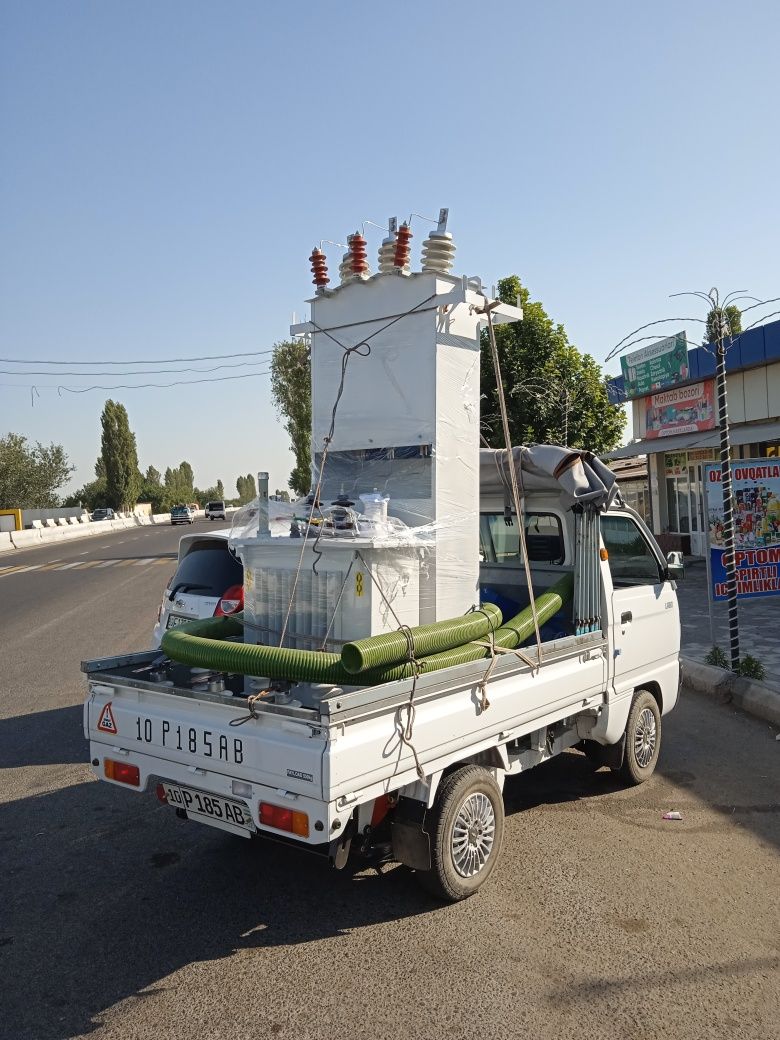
[0,782,439,1040]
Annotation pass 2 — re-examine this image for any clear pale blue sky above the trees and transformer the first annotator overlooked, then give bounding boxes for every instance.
[0,0,780,494]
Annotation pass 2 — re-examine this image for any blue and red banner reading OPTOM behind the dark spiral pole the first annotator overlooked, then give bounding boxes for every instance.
[704,459,780,599]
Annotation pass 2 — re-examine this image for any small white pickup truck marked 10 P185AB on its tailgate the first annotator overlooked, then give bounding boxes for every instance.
[82,449,680,901]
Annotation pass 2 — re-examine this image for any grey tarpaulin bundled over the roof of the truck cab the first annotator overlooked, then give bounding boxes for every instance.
[479,444,619,511]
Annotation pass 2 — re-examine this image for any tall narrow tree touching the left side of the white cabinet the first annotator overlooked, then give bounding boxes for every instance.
[270,340,311,495]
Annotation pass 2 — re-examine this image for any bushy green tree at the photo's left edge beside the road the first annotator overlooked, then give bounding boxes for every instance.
[0,434,75,510]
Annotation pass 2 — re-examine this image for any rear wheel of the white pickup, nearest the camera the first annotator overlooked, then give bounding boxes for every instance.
[417,765,503,903]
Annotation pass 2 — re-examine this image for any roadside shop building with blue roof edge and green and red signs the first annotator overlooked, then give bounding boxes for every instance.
[604,321,780,556]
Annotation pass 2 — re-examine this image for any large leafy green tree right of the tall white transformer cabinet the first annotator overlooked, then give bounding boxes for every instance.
[480,275,626,452]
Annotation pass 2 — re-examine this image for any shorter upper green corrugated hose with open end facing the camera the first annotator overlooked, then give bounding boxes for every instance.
[341,603,501,674]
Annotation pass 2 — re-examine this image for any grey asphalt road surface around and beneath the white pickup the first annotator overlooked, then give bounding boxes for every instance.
[0,522,780,1040]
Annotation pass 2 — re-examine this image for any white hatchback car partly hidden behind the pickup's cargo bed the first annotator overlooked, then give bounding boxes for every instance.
[154,530,243,647]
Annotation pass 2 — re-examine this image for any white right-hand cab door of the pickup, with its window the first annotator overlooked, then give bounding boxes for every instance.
[601,513,680,695]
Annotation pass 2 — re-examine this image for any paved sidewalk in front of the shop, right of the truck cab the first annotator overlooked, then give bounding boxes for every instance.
[677,558,780,692]
